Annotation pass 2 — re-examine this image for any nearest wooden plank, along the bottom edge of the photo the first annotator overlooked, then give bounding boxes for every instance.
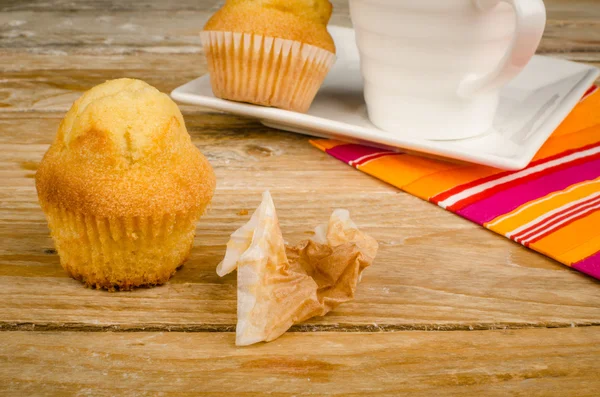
[0,327,600,397]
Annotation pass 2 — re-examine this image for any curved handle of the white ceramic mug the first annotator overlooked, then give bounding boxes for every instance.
[458,0,546,98]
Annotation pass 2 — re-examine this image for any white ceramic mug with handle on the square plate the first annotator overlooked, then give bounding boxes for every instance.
[350,0,546,140]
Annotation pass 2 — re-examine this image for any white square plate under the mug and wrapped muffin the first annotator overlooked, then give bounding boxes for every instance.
[171,27,600,170]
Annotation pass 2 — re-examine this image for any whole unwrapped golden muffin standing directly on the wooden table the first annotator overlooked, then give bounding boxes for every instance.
[36,79,215,290]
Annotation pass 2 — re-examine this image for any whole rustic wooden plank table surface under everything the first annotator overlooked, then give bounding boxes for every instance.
[0,0,600,396]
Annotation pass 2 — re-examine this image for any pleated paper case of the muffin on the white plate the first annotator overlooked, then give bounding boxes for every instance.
[201,31,335,113]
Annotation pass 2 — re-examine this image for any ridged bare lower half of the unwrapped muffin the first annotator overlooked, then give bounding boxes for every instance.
[44,204,200,290]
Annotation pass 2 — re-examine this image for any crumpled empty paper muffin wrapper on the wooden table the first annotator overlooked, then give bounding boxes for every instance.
[217,191,378,346]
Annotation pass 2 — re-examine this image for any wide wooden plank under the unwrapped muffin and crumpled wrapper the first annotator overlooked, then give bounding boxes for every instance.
[0,113,600,330]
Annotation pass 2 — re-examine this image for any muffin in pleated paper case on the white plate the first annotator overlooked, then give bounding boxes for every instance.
[201,0,335,112]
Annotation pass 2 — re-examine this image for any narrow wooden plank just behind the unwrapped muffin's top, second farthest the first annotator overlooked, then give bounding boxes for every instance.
[0,50,600,114]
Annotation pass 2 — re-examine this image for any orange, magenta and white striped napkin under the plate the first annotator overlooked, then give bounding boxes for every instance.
[311,87,600,279]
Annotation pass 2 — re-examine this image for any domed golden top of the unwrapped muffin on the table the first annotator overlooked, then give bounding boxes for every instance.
[36,79,215,217]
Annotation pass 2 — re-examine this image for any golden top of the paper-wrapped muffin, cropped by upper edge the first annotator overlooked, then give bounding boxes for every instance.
[204,0,335,53]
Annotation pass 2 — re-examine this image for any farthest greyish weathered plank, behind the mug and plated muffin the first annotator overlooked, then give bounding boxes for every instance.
[0,0,600,56]
